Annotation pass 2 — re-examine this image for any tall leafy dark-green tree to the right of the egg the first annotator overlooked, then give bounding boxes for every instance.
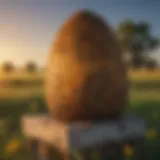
[118,20,159,68]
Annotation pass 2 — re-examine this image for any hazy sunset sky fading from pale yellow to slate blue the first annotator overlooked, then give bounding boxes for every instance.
[0,0,160,65]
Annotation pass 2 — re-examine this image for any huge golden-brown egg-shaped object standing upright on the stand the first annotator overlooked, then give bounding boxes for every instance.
[46,10,127,123]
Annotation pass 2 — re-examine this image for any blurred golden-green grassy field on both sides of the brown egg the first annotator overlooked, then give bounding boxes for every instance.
[0,71,160,160]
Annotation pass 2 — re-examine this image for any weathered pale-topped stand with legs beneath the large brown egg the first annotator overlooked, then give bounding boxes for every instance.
[22,115,146,160]
